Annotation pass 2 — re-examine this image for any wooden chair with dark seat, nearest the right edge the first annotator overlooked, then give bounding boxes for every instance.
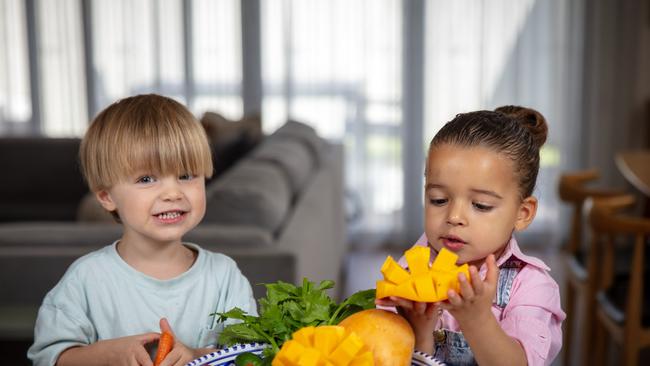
[590,196,650,366]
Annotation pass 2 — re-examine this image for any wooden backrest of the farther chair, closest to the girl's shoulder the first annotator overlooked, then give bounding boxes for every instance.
[558,169,622,255]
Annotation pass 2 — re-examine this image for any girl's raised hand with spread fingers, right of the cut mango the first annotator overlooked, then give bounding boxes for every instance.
[441,254,499,328]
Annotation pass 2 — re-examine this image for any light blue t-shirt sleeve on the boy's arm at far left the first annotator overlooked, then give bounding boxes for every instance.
[27,277,96,366]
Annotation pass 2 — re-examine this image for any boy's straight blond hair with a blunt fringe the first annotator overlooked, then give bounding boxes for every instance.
[79,94,212,192]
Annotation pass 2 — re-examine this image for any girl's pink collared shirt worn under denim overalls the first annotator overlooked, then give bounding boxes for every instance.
[399,234,566,366]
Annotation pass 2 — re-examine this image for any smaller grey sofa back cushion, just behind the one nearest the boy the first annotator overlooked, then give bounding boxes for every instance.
[251,138,316,197]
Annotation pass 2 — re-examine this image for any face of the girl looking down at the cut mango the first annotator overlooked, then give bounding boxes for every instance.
[424,144,537,266]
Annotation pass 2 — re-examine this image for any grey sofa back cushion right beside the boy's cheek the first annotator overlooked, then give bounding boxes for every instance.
[203,158,291,233]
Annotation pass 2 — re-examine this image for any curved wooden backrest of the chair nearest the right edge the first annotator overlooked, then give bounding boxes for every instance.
[589,195,650,324]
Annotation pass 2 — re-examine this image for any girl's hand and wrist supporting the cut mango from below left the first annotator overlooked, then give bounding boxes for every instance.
[375,296,442,354]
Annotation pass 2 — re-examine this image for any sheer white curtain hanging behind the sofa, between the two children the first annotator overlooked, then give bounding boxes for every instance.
[261,0,403,246]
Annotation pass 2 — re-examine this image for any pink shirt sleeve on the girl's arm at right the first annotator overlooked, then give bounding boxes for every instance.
[501,266,565,366]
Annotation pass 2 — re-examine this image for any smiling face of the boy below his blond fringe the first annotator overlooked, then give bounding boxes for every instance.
[97,173,205,245]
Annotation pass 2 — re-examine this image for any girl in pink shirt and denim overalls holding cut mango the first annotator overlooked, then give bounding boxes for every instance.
[377,106,565,366]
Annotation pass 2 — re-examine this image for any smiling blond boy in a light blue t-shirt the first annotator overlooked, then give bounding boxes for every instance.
[28,95,256,366]
